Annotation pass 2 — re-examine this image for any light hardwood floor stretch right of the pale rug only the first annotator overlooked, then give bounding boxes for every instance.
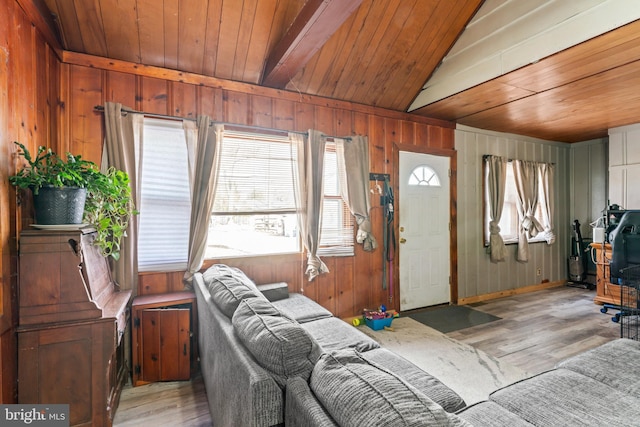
[447,286,620,374]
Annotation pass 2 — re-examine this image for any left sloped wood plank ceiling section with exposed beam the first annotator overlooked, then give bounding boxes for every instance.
[38,0,482,111]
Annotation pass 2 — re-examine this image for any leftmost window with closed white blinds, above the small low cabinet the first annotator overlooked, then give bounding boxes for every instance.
[138,118,191,271]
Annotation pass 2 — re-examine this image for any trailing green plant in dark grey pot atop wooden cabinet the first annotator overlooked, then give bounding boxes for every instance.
[9,142,138,260]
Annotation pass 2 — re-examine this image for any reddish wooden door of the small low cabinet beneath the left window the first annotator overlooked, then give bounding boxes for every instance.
[140,308,191,382]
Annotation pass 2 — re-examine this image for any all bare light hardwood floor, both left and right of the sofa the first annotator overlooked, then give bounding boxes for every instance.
[113,287,620,427]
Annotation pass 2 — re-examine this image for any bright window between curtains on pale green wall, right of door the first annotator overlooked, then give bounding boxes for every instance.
[484,162,545,246]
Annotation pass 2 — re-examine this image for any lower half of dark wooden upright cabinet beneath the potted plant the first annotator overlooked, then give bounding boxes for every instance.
[18,320,127,426]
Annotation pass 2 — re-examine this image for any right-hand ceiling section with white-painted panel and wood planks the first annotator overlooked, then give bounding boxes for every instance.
[409,0,640,142]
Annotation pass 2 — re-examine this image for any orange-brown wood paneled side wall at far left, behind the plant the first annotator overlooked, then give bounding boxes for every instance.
[0,0,60,403]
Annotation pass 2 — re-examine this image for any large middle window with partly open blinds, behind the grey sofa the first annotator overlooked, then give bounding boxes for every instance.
[206,131,300,258]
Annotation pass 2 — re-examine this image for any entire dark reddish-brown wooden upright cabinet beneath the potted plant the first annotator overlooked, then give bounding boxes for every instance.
[17,228,131,427]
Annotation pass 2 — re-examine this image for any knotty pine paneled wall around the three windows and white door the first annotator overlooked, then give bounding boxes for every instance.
[58,52,454,317]
